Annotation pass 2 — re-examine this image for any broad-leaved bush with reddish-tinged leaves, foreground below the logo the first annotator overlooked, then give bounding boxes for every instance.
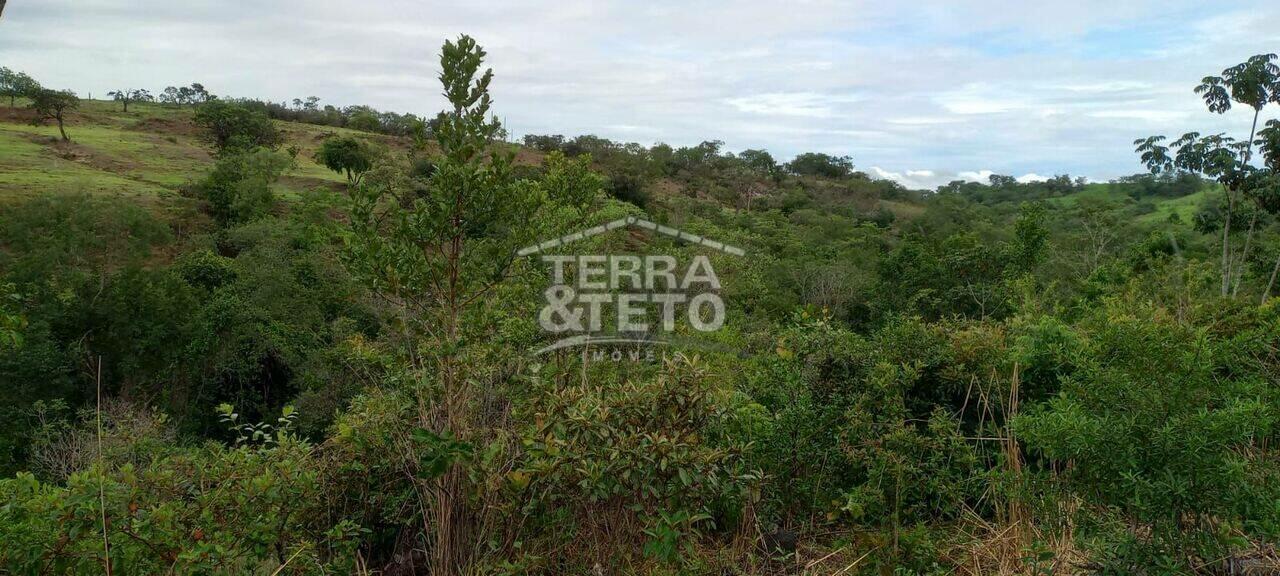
[507,358,755,566]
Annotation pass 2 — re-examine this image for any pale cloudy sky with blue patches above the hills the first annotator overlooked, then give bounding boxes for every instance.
[0,0,1280,187]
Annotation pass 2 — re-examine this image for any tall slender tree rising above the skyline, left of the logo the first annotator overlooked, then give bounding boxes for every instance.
[347,36,545,573]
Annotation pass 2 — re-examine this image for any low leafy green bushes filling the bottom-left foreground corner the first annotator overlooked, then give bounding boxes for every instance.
[0,404,364,573]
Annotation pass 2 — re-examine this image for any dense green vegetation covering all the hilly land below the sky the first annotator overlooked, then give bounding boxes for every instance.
[0,42,1280,575]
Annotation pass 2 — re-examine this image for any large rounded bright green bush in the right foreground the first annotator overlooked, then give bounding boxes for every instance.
[1014,303,1280,565]
